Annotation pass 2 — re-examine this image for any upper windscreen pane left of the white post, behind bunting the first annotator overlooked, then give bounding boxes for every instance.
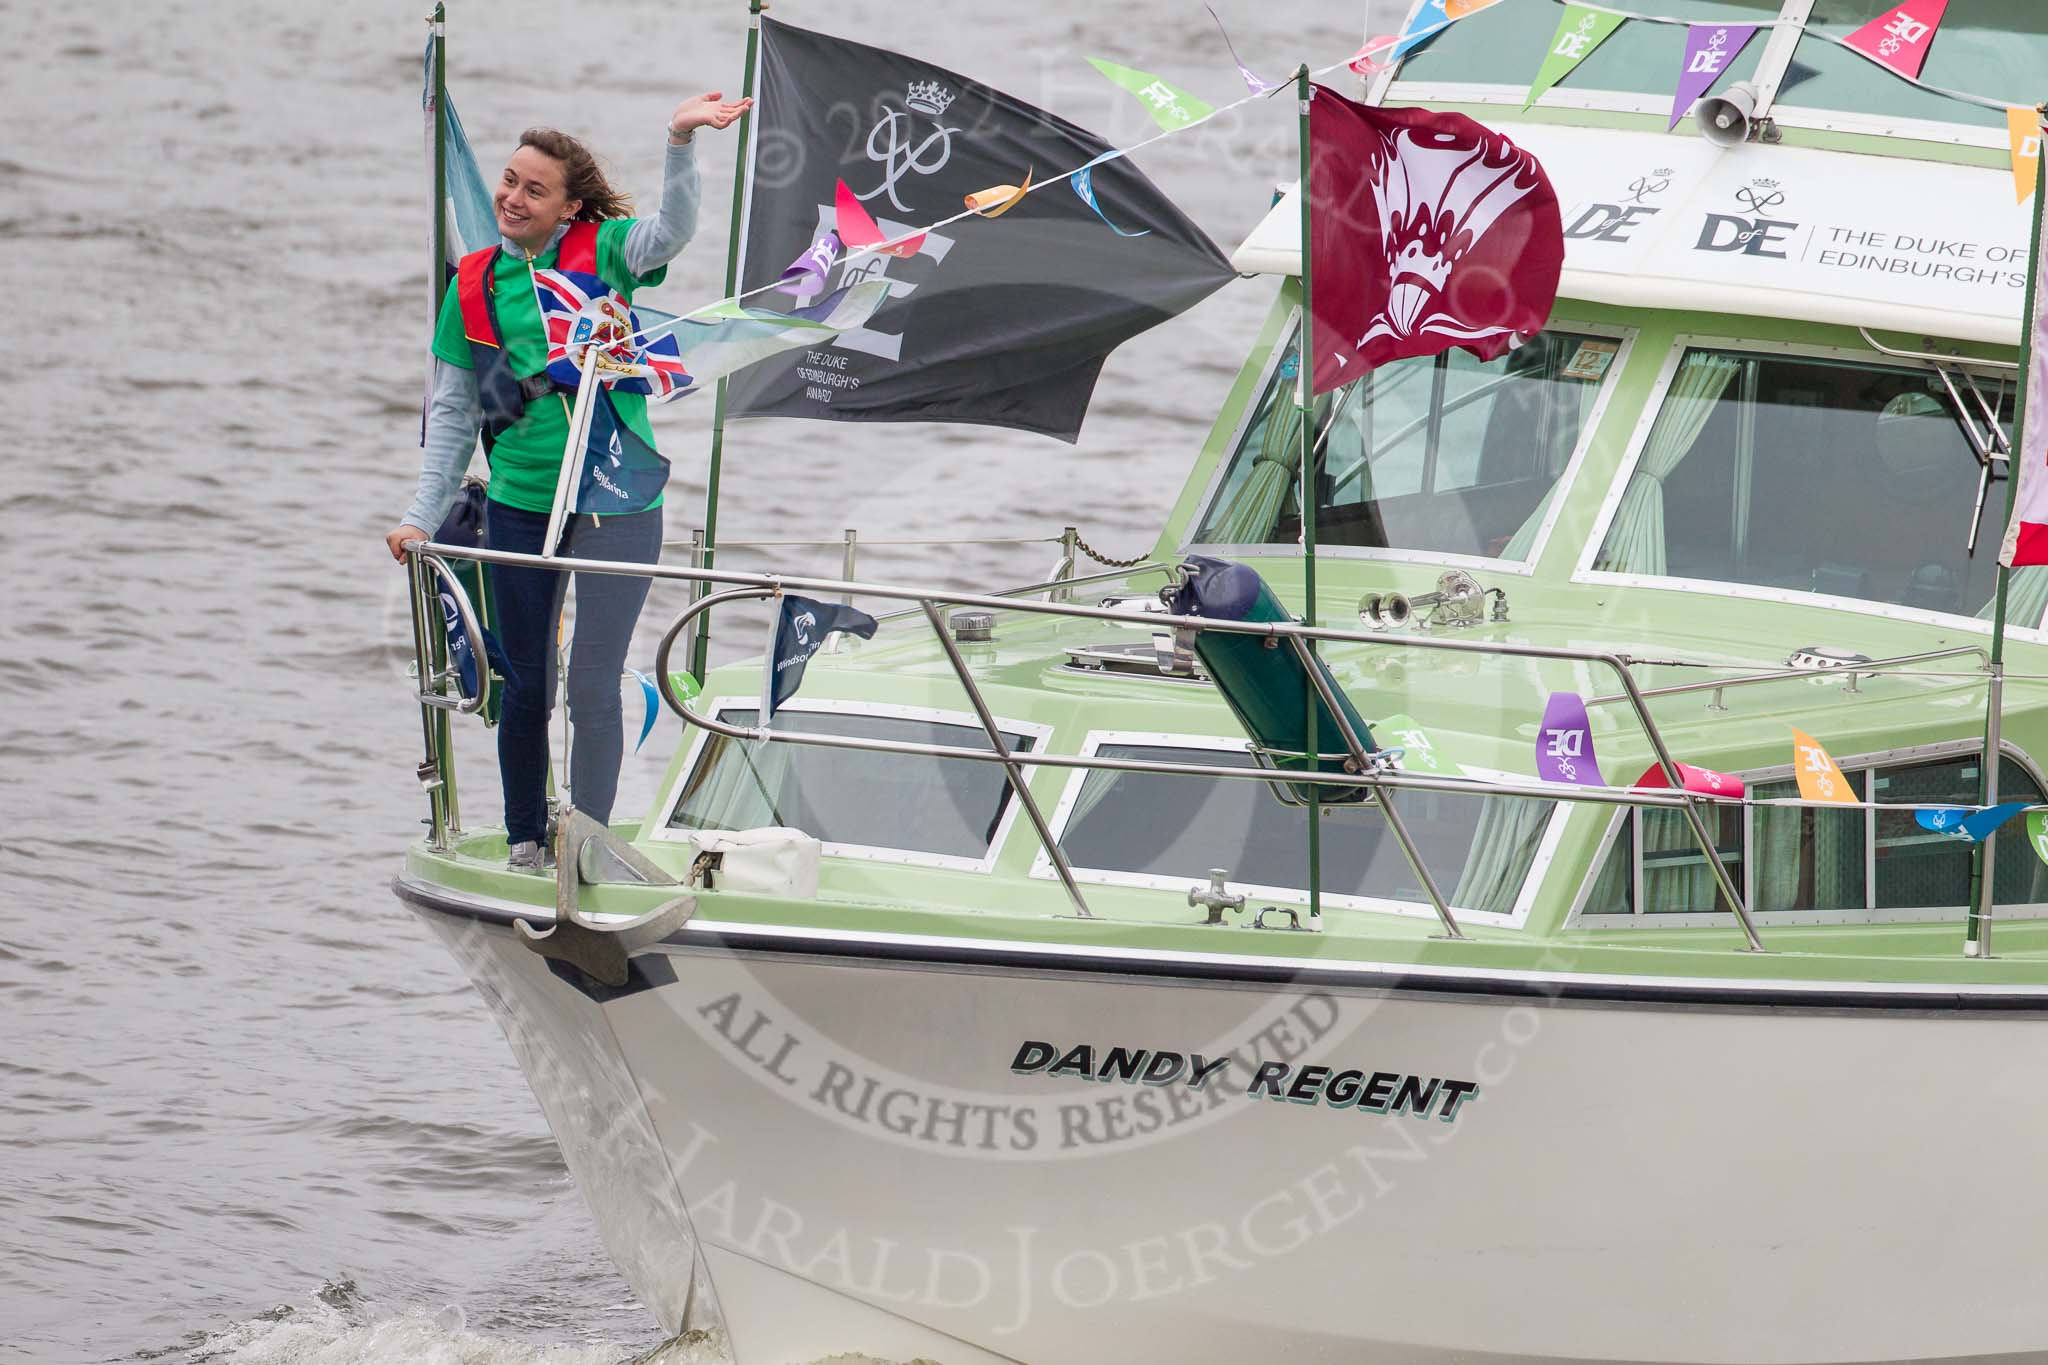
[1389,0,1780,106]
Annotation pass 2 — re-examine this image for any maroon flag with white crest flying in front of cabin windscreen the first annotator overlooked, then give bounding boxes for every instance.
[1309,86,1565,393]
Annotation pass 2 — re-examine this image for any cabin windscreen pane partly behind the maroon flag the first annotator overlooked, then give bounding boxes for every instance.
[1196,332,1620,561]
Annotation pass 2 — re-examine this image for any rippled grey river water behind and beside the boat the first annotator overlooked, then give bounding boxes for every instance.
[0,0,1405,1365]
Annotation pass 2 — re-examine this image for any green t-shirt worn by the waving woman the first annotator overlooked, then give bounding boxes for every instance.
[434,219,668,512]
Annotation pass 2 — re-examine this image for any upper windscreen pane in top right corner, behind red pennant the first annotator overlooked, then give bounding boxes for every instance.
[1777,0,2048,129]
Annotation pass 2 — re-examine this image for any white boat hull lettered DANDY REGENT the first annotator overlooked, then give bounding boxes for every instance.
[399,884,2048,1365]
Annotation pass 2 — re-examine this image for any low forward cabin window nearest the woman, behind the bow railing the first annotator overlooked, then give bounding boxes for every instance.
[668,708,1036,860]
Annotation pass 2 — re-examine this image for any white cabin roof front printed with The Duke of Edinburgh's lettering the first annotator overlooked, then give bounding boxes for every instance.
[1231,123,2030,346]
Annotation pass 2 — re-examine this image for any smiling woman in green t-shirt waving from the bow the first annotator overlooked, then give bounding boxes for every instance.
[385,90,754,870]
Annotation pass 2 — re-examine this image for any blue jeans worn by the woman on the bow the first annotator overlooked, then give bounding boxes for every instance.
[485,501,662,843]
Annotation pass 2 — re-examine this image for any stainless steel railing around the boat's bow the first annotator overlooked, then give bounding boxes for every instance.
[408,540,1810,952]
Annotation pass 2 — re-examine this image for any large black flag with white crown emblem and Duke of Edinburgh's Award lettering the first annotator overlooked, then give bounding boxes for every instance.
[729,20,1231,442]
